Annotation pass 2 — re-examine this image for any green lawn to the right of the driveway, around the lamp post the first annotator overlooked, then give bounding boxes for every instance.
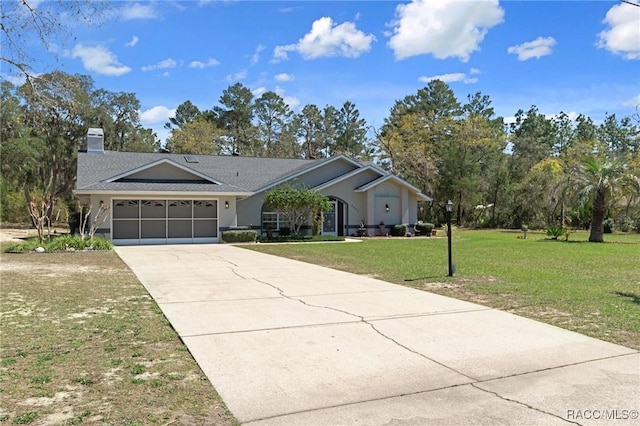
[245,230,640,349]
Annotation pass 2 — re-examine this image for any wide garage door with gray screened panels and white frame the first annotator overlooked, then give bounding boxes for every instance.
[111,200,218,245]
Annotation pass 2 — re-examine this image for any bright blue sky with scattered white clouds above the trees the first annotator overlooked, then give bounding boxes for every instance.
[13,0,640,142]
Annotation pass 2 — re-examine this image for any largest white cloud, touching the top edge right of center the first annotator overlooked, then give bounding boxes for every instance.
[388,0,504,62]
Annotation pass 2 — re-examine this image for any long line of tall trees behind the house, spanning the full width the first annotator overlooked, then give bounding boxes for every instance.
[0,72,640,241]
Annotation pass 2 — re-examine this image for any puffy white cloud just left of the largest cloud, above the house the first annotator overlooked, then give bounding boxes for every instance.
[272,16,376,62]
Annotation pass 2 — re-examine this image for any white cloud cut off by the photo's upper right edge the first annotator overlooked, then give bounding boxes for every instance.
[596,3,640,59]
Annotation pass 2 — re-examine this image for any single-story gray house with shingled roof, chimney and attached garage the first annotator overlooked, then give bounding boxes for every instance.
[75,129,430,245]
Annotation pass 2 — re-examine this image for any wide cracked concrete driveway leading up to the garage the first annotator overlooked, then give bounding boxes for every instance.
[116,244,640,426]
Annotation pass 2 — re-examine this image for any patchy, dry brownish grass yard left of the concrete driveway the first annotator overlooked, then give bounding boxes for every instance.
[0,252,237,426]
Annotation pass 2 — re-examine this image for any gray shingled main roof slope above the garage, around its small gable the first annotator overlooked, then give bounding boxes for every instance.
[76,151,326,193]
